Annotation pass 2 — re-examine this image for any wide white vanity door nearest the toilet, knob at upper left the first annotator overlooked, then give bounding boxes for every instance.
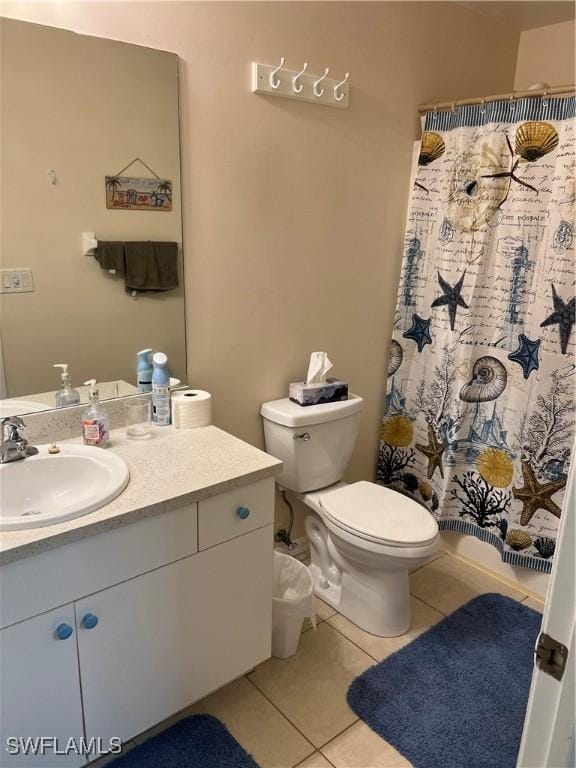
[76,526,273,741]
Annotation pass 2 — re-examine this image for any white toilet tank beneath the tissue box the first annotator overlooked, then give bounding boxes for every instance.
[260,394,364,493]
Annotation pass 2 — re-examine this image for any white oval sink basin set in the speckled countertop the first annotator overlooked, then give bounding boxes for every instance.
[0,445,130,531]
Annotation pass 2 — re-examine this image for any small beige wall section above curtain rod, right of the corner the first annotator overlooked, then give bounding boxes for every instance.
[514,21,576,91]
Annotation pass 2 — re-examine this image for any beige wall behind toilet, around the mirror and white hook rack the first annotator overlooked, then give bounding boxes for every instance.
[3,2,519,536]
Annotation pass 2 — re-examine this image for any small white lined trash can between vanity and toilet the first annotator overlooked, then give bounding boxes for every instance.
[272,552,316,659]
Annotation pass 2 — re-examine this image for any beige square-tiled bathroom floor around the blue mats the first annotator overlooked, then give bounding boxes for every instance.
[90,553,544,768]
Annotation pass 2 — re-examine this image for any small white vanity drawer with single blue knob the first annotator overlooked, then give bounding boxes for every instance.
[198,478,274,550]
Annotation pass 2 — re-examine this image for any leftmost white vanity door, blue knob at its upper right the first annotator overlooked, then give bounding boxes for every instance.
[0,606,85,768]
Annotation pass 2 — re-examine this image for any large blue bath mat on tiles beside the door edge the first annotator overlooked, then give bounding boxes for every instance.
[348,594,542,768]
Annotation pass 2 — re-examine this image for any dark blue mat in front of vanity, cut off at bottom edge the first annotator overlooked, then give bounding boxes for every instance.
[108,715,258,768]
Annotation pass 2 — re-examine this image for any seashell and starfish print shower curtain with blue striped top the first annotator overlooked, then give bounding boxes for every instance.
[377,98,576,572]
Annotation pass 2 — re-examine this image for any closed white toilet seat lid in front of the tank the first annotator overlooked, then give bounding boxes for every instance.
[319,480,438,548]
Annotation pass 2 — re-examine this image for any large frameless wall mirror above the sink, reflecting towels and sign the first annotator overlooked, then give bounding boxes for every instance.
[0,19,186,417]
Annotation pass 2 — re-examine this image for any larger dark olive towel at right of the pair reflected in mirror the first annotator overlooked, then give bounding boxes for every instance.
[125,241,178,291]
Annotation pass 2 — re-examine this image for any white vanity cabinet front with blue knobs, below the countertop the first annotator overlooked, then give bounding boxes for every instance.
[0,477,274,767]
